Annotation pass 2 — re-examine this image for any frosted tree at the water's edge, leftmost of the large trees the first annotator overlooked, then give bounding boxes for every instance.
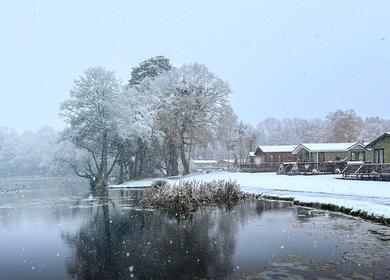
[60,67,124,188]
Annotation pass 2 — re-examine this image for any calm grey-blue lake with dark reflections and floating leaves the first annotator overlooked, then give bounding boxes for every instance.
[0,178,390,280]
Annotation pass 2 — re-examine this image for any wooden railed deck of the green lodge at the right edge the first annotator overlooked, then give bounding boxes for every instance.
[343,162,390,181]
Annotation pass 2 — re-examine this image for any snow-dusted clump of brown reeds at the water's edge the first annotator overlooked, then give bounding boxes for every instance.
[141,180,241,212]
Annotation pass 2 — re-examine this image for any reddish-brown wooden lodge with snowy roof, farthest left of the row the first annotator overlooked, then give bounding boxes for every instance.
[241,145,296,172]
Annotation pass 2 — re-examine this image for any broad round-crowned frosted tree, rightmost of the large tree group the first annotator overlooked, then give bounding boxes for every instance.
[152,64,231,175]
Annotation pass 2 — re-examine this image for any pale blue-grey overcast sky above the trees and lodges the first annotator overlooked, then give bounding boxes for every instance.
[0,0,390,130]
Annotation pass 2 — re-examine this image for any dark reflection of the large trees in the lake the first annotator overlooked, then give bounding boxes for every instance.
[64,192,240,279]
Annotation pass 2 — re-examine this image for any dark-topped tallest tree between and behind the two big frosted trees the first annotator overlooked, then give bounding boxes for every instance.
[114,56,172,183]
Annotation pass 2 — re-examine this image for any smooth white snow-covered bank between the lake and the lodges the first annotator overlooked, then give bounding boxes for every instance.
[112,172,390,218]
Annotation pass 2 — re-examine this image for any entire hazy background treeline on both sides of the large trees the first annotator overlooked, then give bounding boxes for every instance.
[0,111,390,176]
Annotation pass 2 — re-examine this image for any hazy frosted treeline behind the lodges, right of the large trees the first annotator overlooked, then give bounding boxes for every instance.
[190,110,390,160]
